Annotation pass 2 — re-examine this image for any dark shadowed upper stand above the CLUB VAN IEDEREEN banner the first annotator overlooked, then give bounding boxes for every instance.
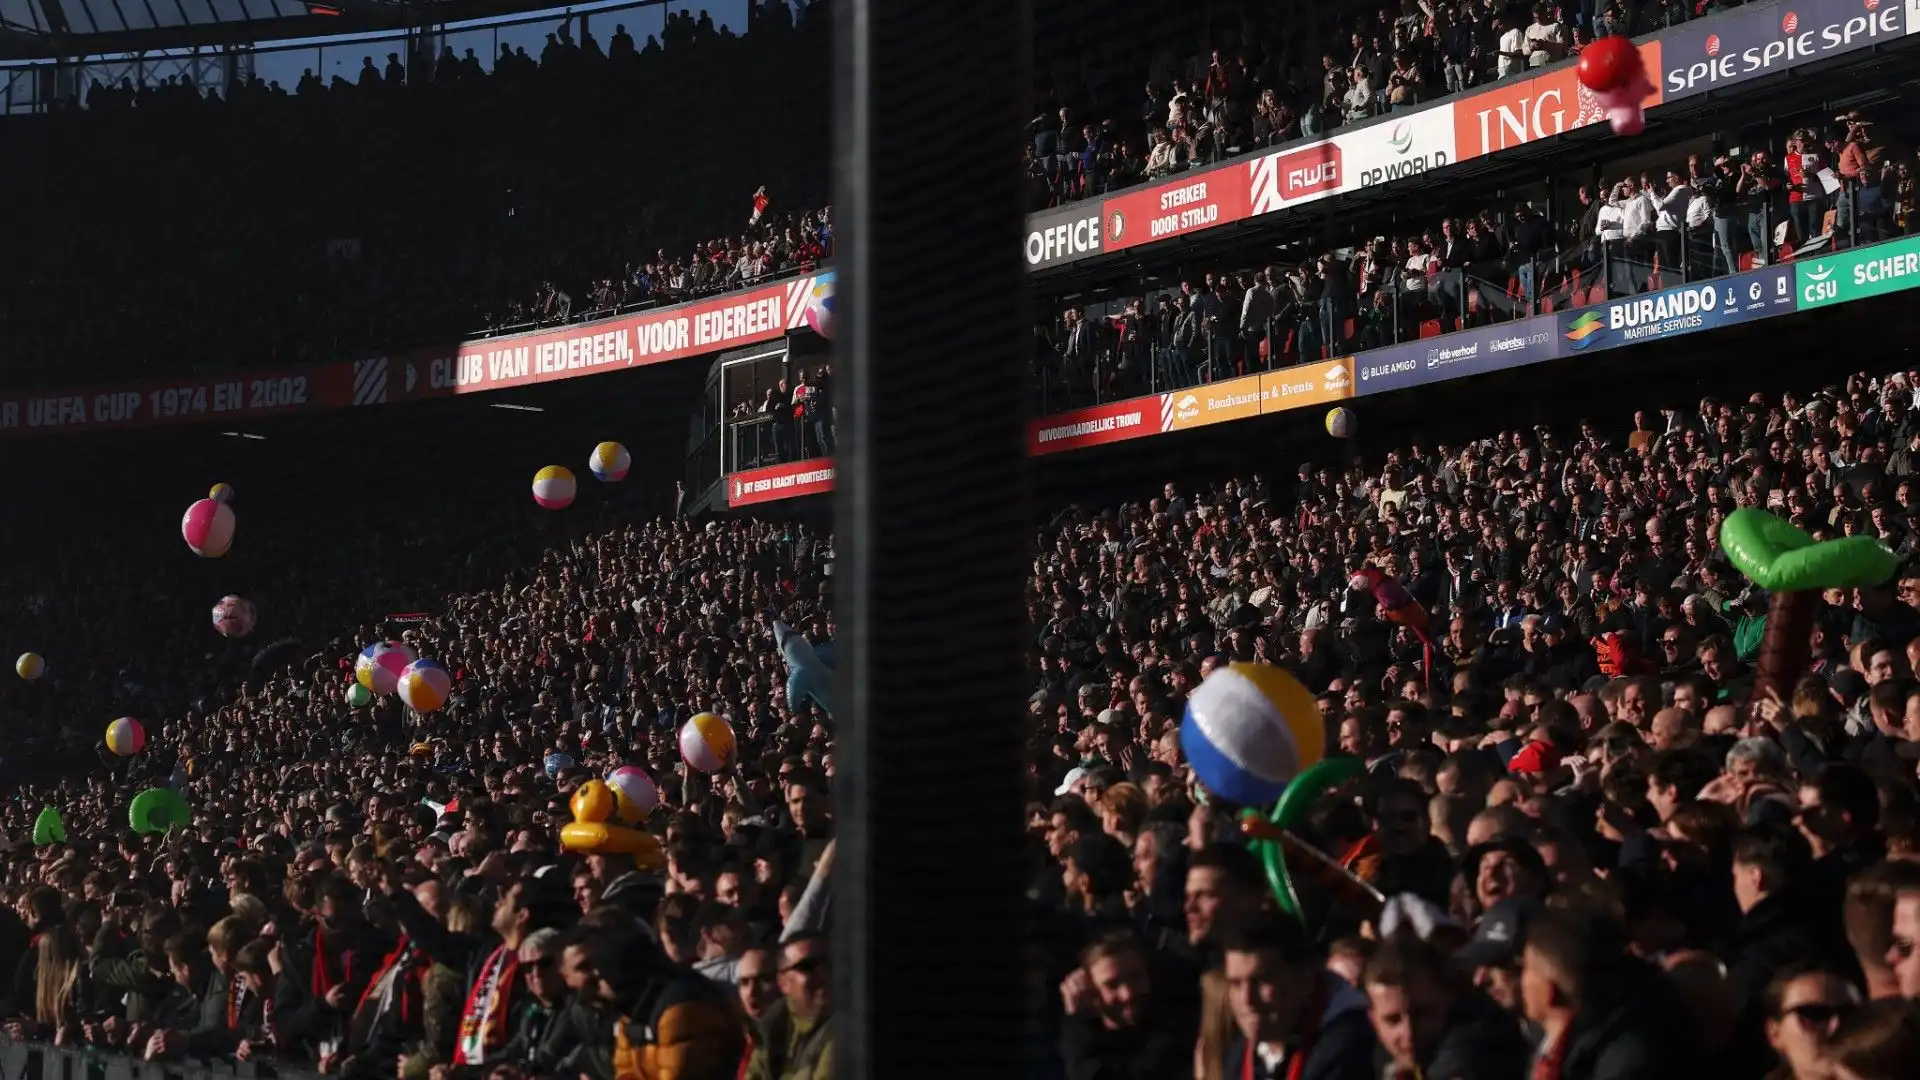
[0,0,833,386]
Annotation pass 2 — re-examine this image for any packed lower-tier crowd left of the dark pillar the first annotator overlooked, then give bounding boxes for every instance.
[0,507,833,1078]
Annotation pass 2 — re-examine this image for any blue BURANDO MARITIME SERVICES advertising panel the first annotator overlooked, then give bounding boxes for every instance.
[1557,265,1795,356]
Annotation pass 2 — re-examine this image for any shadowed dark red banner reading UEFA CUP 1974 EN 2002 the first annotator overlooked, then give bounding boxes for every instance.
[0,363,353,436]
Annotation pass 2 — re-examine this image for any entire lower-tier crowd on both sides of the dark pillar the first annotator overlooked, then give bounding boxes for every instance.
[11,353,1920,1080]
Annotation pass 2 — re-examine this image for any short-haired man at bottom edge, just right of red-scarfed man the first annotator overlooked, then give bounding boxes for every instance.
[1359,932,1530,1080]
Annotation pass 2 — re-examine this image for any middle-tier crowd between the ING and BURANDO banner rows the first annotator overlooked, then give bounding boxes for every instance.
[1031,110,1920,411]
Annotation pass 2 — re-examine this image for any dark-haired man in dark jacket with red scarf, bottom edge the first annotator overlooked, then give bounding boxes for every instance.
[1223,917,1377,1080]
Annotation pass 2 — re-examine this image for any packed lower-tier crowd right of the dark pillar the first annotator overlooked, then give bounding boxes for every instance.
[1029,363,1920,1080]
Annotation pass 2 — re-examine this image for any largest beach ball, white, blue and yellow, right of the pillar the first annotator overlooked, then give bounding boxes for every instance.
[1181,663,1327,807]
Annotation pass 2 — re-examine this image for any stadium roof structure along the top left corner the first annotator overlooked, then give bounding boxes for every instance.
[0,0,606,60]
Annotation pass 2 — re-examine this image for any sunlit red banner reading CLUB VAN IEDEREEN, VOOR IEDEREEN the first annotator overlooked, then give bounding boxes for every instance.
[393,271,833,400]
